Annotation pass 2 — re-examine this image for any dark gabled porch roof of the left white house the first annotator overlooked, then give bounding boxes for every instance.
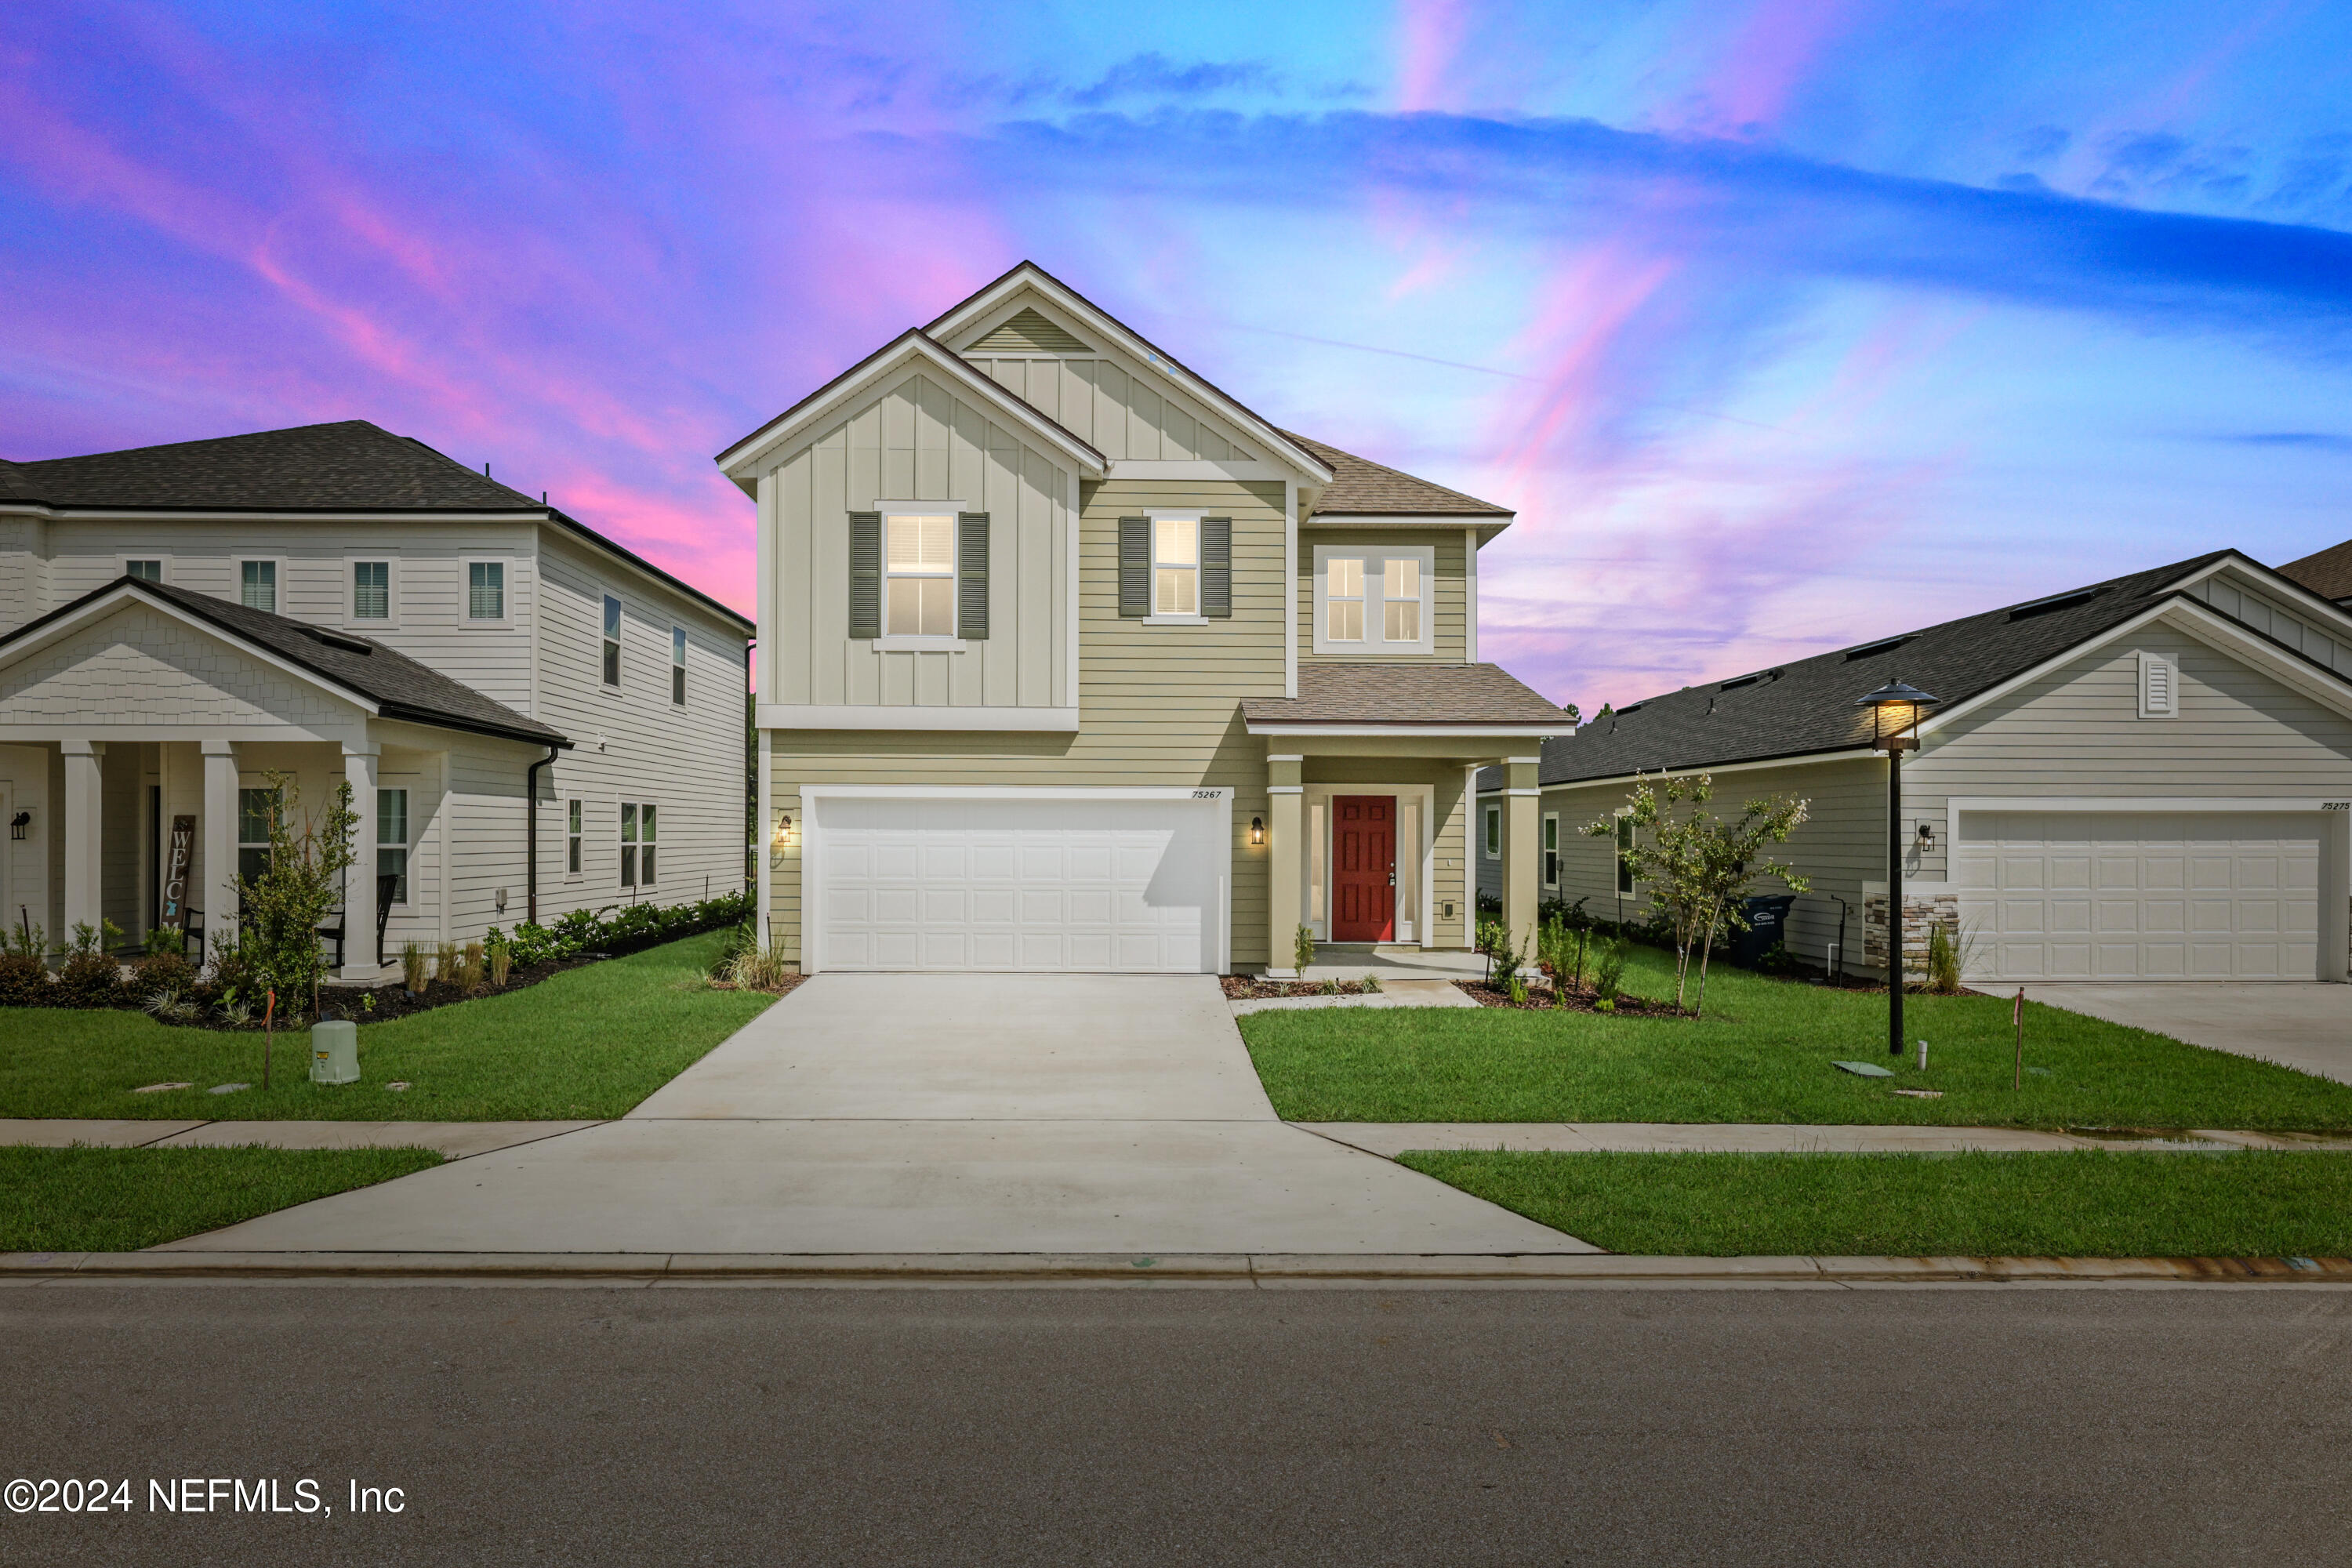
[0,576,572,748]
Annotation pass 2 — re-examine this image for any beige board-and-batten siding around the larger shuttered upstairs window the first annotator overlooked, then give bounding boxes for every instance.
[760,374,1070,708]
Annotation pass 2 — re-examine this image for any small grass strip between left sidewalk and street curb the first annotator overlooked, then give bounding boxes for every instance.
[0,1147,442,1253]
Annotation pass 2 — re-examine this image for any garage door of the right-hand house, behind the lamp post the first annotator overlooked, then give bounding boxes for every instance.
[1952,811,2319,980]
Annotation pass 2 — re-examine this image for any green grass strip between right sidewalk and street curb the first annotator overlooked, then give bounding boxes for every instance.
[1402,1149,2352,1258]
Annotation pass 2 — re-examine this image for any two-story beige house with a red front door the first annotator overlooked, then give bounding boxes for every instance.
[717,263,1569,973]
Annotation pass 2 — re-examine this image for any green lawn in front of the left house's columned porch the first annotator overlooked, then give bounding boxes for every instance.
[0,931,774,1121]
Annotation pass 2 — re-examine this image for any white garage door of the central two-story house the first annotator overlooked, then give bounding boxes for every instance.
[811,797,1230,973]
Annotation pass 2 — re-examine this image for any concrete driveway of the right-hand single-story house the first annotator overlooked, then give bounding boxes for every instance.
[1980,980,2352,1083]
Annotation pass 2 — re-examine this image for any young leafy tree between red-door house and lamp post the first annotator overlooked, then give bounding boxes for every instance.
[1585,774,1811,1018]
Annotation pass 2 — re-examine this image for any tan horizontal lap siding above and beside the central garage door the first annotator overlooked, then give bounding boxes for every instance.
[760,480,1289,966]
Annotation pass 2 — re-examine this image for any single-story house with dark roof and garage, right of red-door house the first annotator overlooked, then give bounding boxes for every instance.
[1482,550,2352,982]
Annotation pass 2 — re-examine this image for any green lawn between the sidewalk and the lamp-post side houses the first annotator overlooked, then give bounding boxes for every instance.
[1242,947,2352,1131]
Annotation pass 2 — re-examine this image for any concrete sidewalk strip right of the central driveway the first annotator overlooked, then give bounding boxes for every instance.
[1294,1121,2352,1159]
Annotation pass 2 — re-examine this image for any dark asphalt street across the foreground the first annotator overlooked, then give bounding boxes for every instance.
[0,1286,2352,1568]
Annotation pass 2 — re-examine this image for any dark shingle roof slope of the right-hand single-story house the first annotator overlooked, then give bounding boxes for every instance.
[1541,550,2230,783]
